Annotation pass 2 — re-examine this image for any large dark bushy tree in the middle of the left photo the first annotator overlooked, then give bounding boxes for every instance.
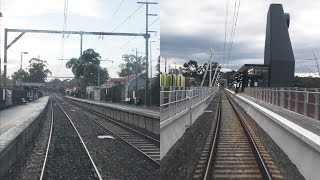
[66,49,109,90]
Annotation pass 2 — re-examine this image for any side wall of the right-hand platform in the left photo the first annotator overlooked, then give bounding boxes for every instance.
[65,96,160,135]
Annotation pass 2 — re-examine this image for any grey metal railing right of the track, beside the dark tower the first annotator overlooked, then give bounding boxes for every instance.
[244,88,320,120]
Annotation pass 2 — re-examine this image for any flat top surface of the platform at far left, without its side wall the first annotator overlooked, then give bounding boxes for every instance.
[0,96,49,148]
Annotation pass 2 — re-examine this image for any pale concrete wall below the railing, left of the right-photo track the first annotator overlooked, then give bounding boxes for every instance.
[160,91,217,159]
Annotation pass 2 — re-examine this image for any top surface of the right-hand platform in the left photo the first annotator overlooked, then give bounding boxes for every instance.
[65,96,160,119]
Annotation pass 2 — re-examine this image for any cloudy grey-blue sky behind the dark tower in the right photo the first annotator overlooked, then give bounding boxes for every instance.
[160,0,320,76]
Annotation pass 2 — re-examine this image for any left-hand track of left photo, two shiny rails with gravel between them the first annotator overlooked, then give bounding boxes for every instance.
[40,97,102,179]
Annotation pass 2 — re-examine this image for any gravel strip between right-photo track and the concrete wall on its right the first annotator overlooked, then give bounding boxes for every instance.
[232,95,304,180]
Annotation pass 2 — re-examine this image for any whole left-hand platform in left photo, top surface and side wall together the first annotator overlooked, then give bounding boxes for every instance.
[0,96,49,176]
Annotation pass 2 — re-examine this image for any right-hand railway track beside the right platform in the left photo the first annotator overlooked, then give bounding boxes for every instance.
[60,96,160,166]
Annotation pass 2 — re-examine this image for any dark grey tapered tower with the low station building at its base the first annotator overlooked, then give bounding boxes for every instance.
[231,4,295,87]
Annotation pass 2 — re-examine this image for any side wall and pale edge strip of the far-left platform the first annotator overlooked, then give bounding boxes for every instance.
[0,98,49,179]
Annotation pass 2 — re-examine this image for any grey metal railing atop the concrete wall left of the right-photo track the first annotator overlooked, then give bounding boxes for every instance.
[160,87,218,121]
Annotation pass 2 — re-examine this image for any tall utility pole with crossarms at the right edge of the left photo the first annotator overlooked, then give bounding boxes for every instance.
[137,2,158,107]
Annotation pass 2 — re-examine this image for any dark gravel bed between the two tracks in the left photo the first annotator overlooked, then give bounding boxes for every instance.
[59,97,160,179]
